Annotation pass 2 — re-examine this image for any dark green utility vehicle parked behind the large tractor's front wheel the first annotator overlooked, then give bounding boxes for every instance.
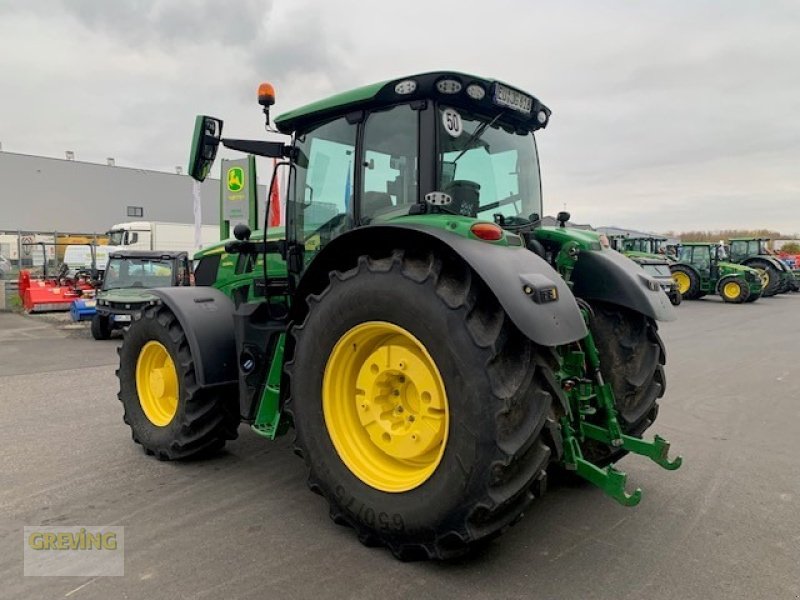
[92,250,191,340]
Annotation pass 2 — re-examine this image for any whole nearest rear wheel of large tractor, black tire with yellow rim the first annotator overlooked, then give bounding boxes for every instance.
[285,251,554,560]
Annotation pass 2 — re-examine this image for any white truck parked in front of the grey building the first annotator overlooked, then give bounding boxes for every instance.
[108,221,219,256]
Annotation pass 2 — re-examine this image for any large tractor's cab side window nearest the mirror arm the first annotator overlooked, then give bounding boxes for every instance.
[292,118,357,259]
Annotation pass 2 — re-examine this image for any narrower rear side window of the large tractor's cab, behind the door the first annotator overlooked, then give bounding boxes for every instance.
[361,104,418,222]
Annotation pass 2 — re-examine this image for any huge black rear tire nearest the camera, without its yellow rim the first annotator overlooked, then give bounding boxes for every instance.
[285,250,555,560]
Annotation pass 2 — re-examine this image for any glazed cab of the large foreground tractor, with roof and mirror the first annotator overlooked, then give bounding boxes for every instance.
[190,72,550,285]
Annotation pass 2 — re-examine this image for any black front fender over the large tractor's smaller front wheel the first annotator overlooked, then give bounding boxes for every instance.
[150,287,239,387]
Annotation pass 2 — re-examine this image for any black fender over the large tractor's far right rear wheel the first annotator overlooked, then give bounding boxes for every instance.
[572,250,676,321]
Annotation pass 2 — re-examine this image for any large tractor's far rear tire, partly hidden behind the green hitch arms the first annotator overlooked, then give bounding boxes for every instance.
[583,302,666,466]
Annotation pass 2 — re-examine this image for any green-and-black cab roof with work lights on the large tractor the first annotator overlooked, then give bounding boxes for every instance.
[275,71,551,134]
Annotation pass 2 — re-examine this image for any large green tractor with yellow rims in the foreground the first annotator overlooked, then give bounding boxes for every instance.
[118,72,681,559]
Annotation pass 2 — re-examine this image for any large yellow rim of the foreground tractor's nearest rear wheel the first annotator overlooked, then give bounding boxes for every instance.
[322,321,449,492]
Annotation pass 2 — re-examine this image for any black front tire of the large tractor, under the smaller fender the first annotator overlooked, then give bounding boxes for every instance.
[117,306,239,460]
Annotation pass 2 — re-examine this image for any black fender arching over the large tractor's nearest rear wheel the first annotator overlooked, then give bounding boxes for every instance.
[299,223,588,346]
